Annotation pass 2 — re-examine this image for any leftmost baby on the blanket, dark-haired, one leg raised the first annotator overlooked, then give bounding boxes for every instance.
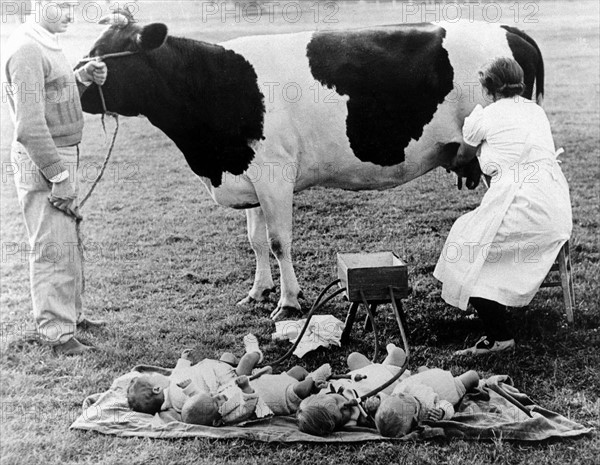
[127,334,262,415]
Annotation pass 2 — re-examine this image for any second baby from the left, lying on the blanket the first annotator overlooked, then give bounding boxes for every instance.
[181,364,331,426]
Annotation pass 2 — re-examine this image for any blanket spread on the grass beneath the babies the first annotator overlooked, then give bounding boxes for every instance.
[71,367,592,443]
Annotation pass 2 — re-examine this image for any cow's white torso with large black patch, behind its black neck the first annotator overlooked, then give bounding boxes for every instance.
[222,23,540,190]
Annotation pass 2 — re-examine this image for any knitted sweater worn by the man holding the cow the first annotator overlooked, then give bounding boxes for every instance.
[4,22,85,179]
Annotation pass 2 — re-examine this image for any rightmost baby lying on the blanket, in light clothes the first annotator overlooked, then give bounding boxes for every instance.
[375,368,479,437]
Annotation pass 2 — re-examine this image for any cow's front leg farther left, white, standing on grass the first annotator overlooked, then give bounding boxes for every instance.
[238,207,275,305]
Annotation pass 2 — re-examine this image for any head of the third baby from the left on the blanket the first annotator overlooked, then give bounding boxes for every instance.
[296,395,342,436]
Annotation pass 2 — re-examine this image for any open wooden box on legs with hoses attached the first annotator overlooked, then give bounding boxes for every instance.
[337,252,408,302]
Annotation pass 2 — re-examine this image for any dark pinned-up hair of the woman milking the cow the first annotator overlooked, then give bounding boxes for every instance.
[479,57,525,99]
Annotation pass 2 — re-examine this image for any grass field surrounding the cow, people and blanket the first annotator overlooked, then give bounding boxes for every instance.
[0,0,600,465]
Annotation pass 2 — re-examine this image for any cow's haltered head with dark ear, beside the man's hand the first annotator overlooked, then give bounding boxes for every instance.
[81,8,167,116]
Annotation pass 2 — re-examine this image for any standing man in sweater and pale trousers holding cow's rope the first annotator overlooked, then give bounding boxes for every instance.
[4,0,107,355]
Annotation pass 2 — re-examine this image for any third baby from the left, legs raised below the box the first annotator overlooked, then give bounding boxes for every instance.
[296,344,410,436]
